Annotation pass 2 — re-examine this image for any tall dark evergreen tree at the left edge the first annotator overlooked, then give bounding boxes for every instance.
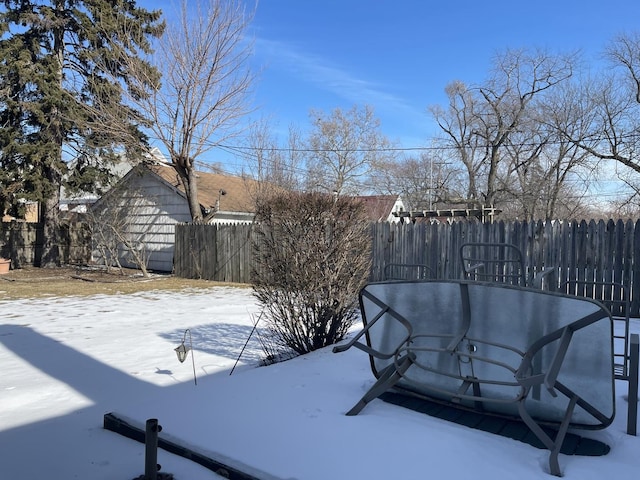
[0,0,164,266]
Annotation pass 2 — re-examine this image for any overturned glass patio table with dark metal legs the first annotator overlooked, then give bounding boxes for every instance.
[334,280,615,476]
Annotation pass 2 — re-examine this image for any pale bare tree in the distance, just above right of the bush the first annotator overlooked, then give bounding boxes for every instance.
[307,106,393,195]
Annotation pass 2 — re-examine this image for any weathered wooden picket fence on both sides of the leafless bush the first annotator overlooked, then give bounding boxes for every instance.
[174,220,640,317]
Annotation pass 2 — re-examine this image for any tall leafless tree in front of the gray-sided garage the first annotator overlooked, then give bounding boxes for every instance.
[126,0,254,222]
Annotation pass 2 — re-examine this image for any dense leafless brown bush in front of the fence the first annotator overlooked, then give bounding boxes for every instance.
[253,192,371,354]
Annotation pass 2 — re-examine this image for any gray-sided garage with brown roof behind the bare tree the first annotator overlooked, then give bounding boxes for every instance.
[90,163,257,272]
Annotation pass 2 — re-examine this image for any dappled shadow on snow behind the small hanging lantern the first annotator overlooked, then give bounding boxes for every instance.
[164,323,265,364]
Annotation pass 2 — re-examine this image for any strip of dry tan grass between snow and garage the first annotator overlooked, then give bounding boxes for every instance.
[0,267,242,300]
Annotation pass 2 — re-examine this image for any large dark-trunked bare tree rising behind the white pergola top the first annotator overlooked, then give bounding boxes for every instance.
[431,50,573,210]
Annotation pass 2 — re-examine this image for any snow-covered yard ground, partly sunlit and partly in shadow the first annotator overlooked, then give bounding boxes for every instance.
[0,287,640,480]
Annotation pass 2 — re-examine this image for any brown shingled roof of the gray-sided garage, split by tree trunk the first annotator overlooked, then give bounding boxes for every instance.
[146,164,258,212]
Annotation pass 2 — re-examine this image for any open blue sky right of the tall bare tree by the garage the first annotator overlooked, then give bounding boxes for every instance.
[251,0,640,147]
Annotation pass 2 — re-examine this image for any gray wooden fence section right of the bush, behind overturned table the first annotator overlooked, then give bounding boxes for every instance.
[371,220,640,316]
